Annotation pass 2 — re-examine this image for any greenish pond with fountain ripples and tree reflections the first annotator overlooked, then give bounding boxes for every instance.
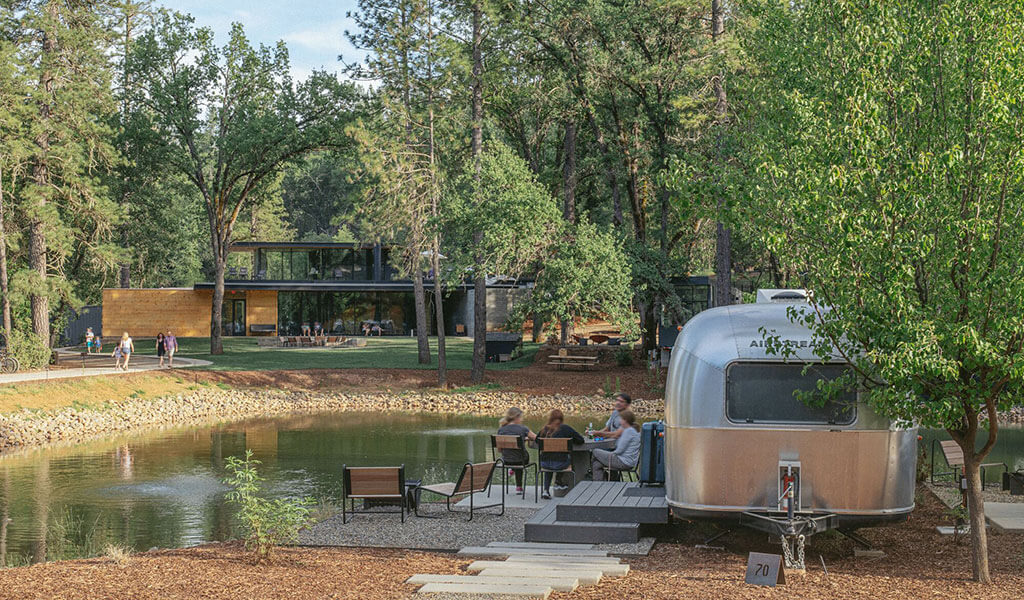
[0,413,1024,565]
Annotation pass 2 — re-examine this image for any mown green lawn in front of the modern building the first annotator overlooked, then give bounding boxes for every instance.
[135,337,540,371]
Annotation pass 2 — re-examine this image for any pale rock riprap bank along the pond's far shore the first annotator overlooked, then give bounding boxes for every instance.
[0,389,665,452]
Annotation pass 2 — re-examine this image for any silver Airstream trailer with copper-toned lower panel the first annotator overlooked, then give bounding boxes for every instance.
[665,291,918,542]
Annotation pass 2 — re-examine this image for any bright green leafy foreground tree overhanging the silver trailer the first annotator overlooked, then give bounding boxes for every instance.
[744,0,1024,583]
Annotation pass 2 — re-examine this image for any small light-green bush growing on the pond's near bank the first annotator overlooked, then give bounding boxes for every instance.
[224,449,315,562]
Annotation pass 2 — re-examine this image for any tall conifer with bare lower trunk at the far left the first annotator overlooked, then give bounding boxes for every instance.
[13,0,119,343]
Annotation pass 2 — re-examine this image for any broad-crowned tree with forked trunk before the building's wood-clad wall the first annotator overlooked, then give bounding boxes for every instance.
[127,12,359,354]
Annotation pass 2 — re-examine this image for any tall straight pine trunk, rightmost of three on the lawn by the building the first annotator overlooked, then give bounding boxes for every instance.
[470,0,487,383]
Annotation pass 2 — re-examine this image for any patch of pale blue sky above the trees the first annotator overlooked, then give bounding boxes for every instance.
[158,0,365,80]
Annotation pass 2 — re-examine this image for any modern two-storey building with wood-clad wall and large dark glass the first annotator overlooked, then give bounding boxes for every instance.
[101,242,526,337]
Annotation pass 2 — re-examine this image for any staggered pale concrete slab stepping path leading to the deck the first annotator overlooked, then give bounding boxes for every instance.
[406,542,630,600]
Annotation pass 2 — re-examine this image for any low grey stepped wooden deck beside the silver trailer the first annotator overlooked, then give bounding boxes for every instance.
[525,481,669,544]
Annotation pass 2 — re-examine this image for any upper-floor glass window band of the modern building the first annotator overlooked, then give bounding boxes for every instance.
[255,248,385,282]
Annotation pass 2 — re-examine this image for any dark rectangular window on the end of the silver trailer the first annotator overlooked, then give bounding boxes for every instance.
[726,362,857,425]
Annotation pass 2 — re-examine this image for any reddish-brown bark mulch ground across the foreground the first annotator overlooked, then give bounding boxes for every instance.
[0,489,1024,600]
